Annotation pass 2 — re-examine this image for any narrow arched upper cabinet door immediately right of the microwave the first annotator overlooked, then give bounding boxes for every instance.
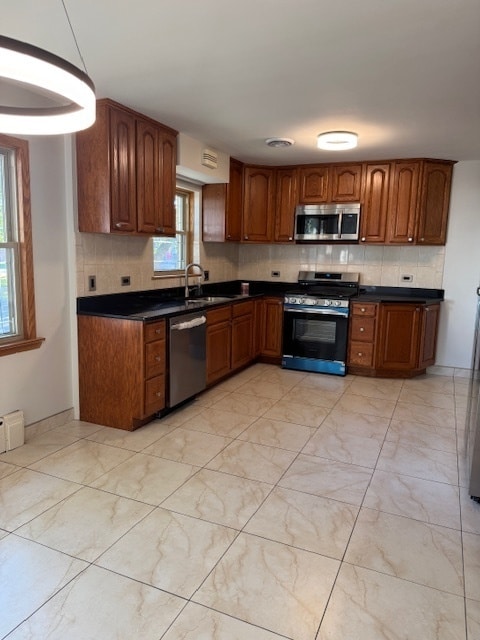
[360,163,390,244]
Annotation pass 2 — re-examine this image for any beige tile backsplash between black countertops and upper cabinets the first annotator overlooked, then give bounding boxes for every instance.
[76,233,445,296]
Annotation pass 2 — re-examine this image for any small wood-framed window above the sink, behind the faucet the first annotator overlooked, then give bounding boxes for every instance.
[153,188,193,275]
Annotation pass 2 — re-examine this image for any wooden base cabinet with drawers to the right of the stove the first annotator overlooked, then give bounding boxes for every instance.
[348,302,440,378]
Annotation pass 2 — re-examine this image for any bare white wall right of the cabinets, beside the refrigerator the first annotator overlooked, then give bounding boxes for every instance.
[437,160,480,368]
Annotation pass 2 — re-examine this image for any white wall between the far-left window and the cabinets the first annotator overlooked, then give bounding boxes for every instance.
[0,136,76,424]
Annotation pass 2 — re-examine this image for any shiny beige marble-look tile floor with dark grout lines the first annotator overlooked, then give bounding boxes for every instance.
[0,364,480,640]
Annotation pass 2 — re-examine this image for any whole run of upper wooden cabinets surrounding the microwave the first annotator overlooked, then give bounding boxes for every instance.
[203,159,454,245]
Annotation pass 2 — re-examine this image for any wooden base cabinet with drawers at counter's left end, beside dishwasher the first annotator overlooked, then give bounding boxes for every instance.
[78,315,166,431]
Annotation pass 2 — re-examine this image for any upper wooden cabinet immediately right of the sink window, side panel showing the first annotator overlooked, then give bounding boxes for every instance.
[202,158,243,242]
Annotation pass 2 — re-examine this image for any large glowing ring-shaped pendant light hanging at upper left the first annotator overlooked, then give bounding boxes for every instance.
[0,26,95,135]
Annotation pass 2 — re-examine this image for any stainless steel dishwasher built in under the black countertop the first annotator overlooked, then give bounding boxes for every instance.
[168,311,207,407]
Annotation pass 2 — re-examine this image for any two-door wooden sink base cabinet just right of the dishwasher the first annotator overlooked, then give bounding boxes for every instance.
[207,300,255,385]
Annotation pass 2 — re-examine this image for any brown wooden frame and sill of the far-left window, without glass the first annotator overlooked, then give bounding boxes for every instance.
[0,133,45,356]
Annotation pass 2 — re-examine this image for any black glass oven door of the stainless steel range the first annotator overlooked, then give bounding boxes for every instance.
[283,311,348,362]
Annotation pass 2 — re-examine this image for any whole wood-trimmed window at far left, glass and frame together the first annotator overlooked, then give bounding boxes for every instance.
[0,135,43,355]
